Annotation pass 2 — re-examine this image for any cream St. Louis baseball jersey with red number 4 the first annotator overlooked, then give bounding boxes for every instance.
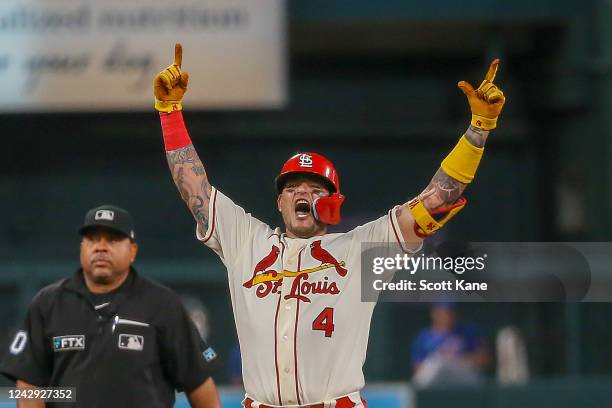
[197,188,415,405]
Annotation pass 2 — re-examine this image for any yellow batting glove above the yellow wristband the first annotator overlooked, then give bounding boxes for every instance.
[457,59,506,130]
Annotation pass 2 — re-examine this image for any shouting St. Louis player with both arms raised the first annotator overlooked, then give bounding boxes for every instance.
[154,44,505,408]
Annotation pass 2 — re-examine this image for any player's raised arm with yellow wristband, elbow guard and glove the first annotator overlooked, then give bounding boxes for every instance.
[396,59,506,242]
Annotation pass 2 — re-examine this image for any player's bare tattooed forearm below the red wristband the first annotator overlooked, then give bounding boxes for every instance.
[166,145,212,231]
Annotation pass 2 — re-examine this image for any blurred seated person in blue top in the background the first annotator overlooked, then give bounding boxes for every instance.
[411,302,490,387]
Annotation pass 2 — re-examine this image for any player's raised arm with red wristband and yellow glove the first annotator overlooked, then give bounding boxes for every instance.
[153,44,212,234]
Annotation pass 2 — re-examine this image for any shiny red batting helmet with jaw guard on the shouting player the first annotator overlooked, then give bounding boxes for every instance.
[276,152,344,225]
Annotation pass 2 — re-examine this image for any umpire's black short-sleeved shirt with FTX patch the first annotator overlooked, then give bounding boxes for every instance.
[0,269,214,408]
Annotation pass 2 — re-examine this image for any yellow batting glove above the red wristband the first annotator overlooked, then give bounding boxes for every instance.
[153,43,189,113]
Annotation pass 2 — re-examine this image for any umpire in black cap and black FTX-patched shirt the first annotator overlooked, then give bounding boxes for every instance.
[0,205,221,408]
